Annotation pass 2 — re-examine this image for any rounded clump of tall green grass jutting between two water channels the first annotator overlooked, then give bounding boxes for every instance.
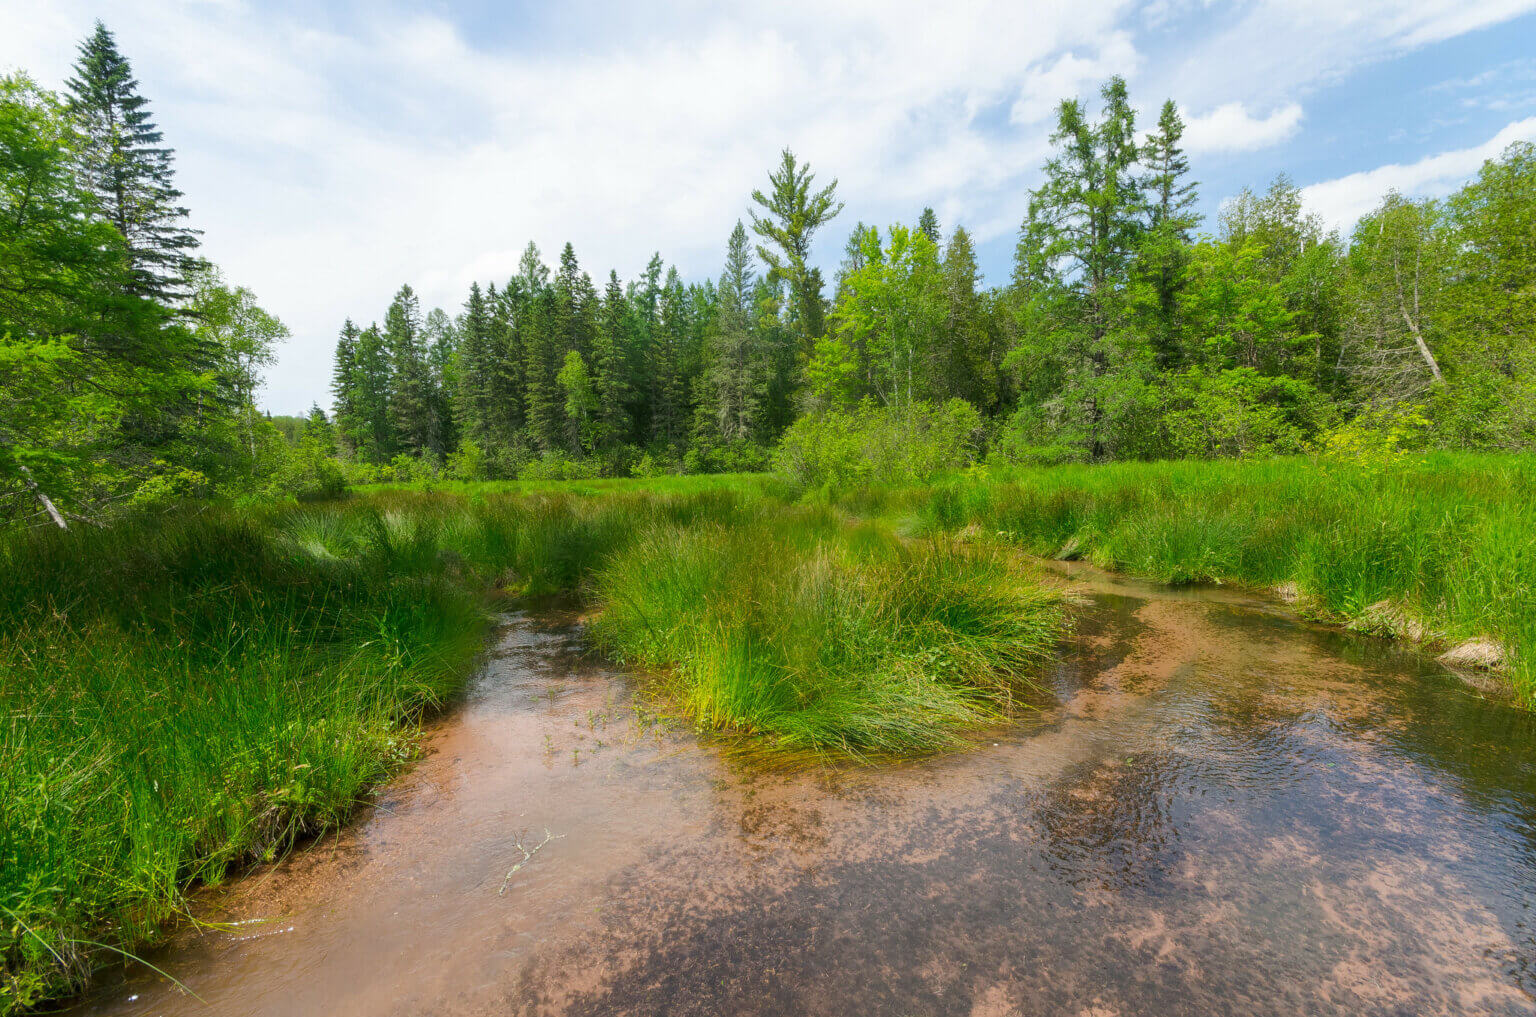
[594,509,1057,754]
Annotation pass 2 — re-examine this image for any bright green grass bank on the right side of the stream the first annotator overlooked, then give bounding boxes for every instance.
[866,455,1536,705]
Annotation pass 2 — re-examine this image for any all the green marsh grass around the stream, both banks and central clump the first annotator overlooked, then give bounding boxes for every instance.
[12,456,1536,1012]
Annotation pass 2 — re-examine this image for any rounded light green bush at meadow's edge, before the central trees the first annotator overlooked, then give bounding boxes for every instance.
[774,399,983,490]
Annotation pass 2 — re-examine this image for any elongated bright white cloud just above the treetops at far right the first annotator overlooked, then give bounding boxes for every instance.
[1301,117,1536,229]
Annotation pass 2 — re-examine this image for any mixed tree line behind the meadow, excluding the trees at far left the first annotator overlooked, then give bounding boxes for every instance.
[333,77,1536,476]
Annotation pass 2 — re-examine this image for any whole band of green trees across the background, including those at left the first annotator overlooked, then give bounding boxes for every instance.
[0,25,1536,525]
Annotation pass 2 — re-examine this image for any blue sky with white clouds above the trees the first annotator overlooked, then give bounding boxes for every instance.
[0,0,1536,413]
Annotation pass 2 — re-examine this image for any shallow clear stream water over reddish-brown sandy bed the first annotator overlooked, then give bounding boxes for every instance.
[74,571,1536,1017]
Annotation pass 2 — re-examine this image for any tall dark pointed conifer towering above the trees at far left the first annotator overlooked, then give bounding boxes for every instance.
[66,22,200,303]
